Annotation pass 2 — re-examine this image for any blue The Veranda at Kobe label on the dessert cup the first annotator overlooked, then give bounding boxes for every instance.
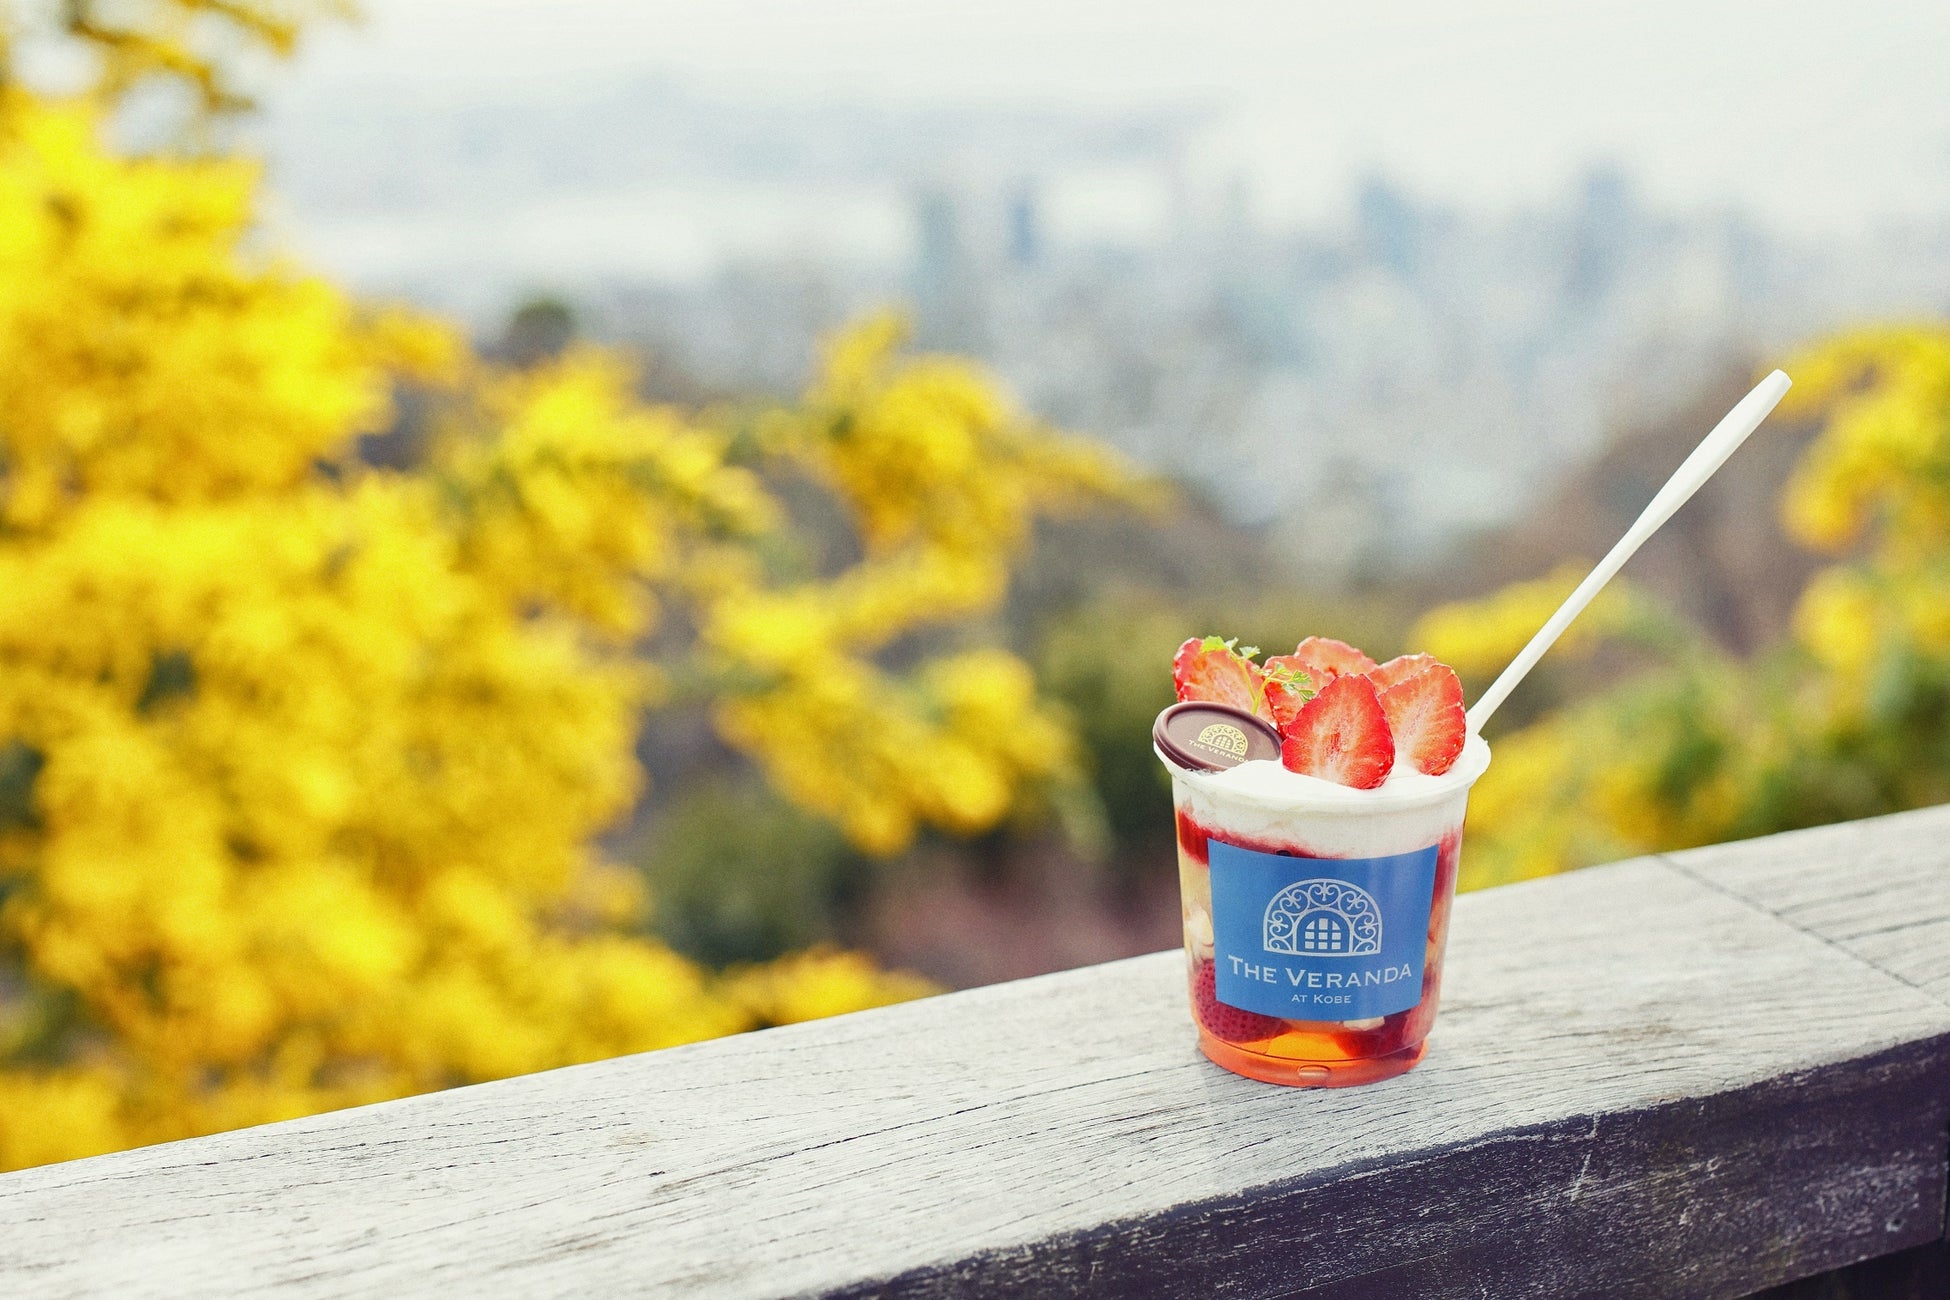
[1211,840,1435,1019]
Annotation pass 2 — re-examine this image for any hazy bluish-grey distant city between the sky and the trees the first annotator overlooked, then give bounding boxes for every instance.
[271,86,1950,579]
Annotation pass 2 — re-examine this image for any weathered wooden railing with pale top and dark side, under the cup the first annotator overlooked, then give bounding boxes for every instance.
[0,813,1950,1298]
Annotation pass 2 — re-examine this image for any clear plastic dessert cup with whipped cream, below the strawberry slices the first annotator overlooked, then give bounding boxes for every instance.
[1158,739,1490,1088]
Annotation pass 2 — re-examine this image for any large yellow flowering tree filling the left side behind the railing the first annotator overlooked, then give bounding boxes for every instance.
[0,0,1133,1167]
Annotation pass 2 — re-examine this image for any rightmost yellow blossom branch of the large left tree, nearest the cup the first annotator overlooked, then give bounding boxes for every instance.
[702,318,1147,854]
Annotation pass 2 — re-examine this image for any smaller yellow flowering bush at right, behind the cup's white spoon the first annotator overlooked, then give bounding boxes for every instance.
[1416,325,1950,885]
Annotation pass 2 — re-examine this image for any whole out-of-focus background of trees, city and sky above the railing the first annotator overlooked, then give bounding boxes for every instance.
[0,0,1950,1166]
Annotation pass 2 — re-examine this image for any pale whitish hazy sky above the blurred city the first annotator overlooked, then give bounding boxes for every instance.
[274,0,1950,232]
